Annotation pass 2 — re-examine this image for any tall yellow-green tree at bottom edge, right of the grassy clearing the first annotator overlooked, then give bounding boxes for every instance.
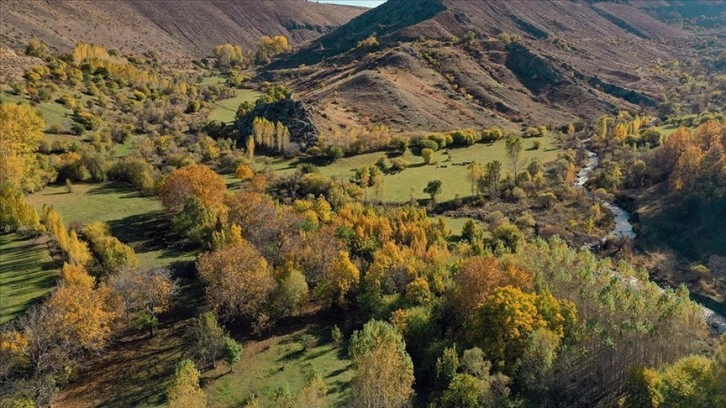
[349,320,414,408]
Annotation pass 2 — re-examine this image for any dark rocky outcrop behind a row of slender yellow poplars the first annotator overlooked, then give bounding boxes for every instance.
[236,99,320,150]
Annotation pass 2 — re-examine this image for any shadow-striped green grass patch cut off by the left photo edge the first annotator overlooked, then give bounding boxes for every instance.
[0,234,58,323]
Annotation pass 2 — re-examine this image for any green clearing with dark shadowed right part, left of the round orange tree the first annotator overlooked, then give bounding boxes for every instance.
[28,183,196,267]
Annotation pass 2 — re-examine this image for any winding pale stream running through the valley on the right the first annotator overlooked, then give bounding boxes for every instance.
[575,139,726,335]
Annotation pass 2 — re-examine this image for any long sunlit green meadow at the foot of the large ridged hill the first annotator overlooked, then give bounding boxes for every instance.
[270,137,560,203]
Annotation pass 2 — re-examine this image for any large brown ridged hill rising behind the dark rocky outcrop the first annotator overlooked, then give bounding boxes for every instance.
[267,0,691,131]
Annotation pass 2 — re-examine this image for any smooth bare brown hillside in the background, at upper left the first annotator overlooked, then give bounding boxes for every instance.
[0,0,366,59]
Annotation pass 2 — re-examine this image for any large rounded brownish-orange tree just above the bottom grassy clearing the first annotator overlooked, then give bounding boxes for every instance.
[197,241,277,319]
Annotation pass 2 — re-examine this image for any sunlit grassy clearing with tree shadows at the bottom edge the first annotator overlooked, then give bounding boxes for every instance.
[205,326,353,407]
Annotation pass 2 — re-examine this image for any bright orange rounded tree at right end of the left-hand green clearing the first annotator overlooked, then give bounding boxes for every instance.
[159,164,227,212]
